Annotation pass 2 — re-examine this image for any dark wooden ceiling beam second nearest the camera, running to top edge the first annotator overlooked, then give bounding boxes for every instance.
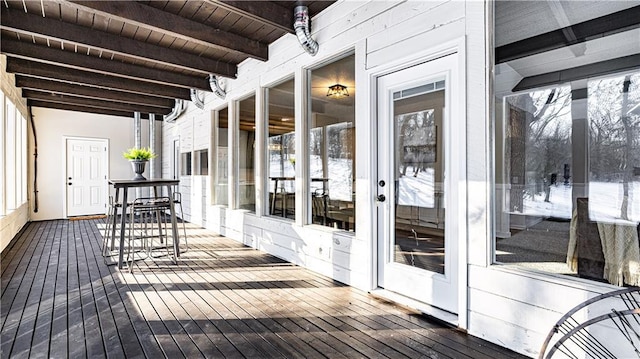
[65,1,269,61]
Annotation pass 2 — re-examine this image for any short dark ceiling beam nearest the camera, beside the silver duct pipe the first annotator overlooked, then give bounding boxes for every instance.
[207,0,295,34]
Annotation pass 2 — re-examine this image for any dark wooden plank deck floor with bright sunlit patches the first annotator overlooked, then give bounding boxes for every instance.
[0,220,521,359]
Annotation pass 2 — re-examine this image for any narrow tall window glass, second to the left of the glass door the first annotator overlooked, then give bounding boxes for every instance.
[266,80,296,219]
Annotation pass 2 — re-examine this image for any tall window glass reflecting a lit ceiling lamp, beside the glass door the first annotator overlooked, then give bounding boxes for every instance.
[308,55,356,231]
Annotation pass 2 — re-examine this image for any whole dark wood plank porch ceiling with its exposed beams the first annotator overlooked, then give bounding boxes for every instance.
[0,0,334,119]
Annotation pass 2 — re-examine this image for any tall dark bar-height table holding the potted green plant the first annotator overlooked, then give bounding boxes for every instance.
[109,178,180,269]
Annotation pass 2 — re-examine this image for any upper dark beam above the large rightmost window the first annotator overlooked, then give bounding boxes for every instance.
[495,6,640,64]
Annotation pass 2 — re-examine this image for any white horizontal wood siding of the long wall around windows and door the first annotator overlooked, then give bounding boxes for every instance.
[158,1,628,356]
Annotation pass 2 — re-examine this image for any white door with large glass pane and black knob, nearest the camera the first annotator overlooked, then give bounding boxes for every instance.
[376,54,465,314]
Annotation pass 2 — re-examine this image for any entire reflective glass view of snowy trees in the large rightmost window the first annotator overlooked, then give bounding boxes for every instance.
[496,73,640,286]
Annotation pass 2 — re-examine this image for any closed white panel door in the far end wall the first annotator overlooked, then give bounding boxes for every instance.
[66,138,107,217]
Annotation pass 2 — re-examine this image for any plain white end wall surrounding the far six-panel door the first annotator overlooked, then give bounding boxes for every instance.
[29,107,142,221]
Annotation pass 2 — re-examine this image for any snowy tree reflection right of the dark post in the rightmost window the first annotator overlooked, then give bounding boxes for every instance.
[583,74,640,223]
